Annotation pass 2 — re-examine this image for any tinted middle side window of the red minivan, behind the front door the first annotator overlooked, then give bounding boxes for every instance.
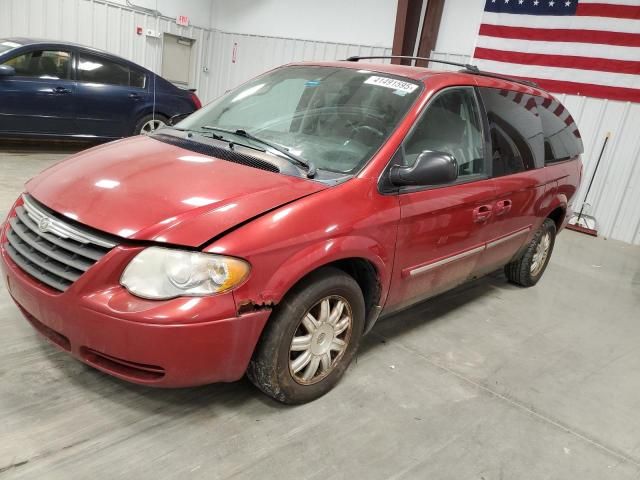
[480,88,544,177]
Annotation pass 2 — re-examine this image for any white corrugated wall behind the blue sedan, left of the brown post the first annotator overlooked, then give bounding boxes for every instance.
[0,0,391,103]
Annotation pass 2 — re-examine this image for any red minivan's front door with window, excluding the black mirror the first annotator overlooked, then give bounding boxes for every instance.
[387,87,495,311]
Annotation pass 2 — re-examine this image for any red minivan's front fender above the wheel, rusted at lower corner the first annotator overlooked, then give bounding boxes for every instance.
[204,179,400,316]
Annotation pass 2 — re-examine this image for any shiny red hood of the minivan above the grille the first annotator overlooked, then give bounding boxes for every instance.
[27,137,326,247]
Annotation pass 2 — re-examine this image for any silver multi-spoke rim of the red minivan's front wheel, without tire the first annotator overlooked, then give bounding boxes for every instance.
[289,295,353,385]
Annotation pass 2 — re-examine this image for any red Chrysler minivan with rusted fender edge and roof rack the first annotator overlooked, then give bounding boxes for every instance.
[1,58,582,403]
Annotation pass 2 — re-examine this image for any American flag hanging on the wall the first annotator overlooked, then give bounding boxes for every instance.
[473,0,640,102]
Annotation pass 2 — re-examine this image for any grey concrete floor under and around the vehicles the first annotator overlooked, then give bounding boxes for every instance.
[0,146,640,480]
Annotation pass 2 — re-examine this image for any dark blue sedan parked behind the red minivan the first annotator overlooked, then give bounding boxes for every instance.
[0,38,201,139]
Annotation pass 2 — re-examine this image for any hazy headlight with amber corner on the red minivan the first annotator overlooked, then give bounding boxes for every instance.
[120,247,250,299]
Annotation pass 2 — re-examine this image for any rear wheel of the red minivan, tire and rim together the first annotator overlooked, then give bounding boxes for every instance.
[504,218,556,287]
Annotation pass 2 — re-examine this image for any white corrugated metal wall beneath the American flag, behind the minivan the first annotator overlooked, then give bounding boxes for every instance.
[431,52,640,245]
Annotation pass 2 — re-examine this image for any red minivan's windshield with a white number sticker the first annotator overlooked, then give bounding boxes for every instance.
[176,66,420,174]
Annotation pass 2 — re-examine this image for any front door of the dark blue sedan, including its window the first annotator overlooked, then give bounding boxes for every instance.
[0,49,76,135]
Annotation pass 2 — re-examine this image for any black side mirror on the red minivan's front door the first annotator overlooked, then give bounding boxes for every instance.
[389,150,458,187]
